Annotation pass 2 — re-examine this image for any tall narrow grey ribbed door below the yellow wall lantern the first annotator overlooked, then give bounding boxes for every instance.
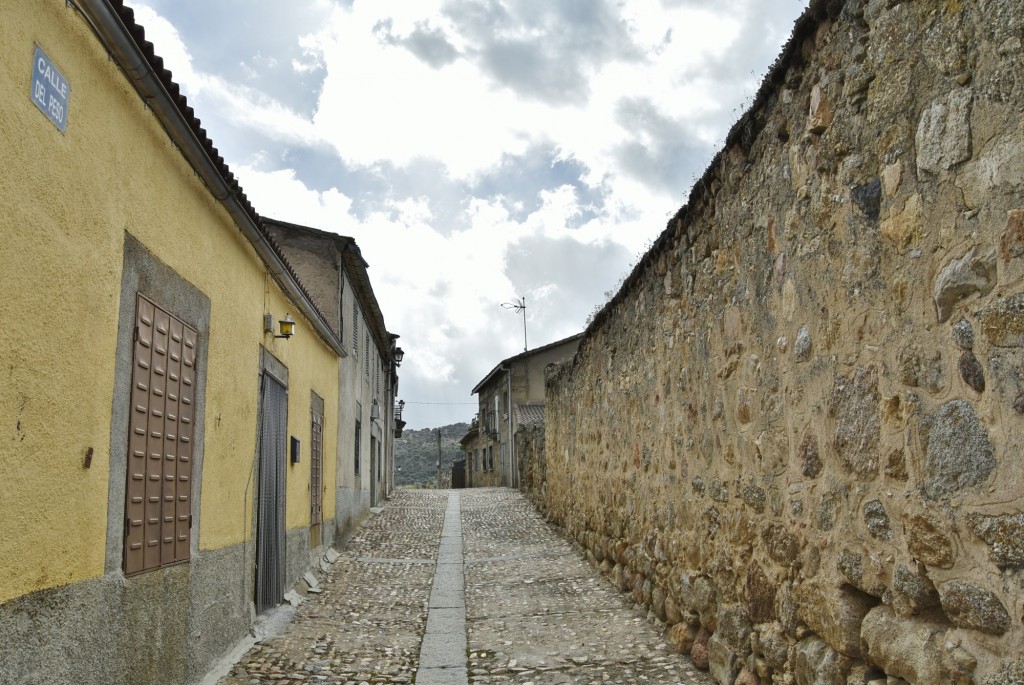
[256,373,288,611]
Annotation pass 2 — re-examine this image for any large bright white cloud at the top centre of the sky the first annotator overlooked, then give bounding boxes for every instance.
[314,3,536,177]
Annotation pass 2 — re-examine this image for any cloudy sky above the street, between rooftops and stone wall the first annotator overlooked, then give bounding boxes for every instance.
[128,0,807,428]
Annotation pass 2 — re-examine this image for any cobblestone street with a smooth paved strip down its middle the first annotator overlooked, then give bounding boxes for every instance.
[220,488,712,685]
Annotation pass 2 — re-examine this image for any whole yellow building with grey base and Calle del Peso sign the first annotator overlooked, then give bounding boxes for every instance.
[0,0,393,684]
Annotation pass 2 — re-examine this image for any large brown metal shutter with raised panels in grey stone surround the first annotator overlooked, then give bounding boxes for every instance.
[124,295,199,575]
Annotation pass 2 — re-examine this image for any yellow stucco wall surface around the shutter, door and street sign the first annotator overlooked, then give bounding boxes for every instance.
[0,0,339,602]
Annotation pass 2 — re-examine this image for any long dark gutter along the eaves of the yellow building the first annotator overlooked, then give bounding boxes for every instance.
[77,0,348,357]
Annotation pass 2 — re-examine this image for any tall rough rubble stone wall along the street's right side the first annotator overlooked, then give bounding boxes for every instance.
[527,0,1024,685]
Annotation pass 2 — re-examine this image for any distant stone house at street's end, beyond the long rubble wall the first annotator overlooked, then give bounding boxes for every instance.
[460,334,582,487]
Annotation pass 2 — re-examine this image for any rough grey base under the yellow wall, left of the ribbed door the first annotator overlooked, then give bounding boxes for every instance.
[0,545,252,685]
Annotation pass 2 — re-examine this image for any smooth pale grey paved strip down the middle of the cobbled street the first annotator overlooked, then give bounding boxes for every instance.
[416,493,469,685]
